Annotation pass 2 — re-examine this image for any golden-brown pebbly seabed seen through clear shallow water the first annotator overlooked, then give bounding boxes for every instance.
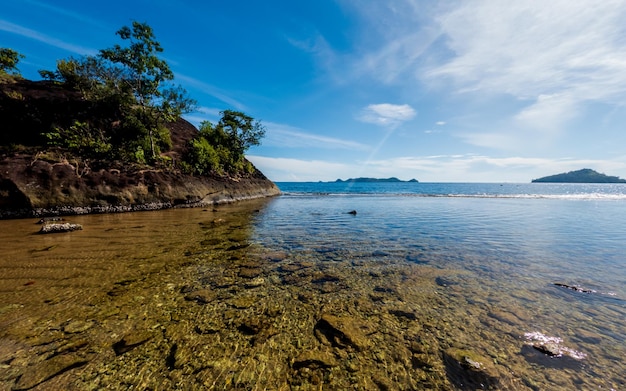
[0,200,624,390]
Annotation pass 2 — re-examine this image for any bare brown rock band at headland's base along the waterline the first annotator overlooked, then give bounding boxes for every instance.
[0,155,280,219]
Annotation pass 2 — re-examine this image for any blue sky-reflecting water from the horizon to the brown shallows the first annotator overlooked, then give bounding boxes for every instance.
[270,183,626,292]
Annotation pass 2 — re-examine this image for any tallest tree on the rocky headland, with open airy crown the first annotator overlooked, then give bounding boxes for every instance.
[39,21,196,162]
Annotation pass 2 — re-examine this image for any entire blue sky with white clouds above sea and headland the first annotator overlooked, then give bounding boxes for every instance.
[0,0,626,183]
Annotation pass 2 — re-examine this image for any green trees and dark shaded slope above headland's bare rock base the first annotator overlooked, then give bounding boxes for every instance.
[0,21,265,177]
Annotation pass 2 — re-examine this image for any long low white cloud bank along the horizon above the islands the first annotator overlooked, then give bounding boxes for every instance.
[247,154,626,183]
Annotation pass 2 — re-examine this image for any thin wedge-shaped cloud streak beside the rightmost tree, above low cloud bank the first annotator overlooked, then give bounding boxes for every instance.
[263,122,370,151]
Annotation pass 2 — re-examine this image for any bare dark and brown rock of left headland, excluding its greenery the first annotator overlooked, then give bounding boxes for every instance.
[0,81,280,218]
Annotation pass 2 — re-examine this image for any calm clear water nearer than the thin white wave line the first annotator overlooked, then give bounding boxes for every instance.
[0,197,626,390]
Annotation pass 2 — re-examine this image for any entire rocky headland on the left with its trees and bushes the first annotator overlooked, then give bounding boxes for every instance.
[0,22,279,218]
